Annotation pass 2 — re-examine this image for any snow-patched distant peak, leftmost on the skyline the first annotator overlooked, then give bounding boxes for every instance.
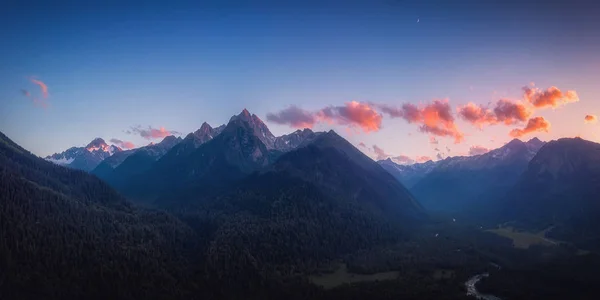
[46,138,123,172]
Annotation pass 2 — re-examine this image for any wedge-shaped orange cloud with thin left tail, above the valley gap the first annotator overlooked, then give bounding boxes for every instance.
[378,100,464,143]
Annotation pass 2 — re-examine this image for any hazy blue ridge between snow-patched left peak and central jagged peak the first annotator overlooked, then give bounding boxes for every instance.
[91,135,182,185]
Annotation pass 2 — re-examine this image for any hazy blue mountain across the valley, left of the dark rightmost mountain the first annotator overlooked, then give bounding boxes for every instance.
[411,138,544,211]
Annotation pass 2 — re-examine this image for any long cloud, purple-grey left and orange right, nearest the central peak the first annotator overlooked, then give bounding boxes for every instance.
[267,101,383,133]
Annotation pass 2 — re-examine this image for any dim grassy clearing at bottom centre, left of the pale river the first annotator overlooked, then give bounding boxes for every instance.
[309,264,399,289]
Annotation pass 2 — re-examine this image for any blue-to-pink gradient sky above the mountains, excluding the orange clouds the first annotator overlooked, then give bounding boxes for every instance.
[0,0,600,162]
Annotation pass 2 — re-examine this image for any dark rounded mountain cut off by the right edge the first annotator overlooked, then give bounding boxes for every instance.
[499,138,600,250]
